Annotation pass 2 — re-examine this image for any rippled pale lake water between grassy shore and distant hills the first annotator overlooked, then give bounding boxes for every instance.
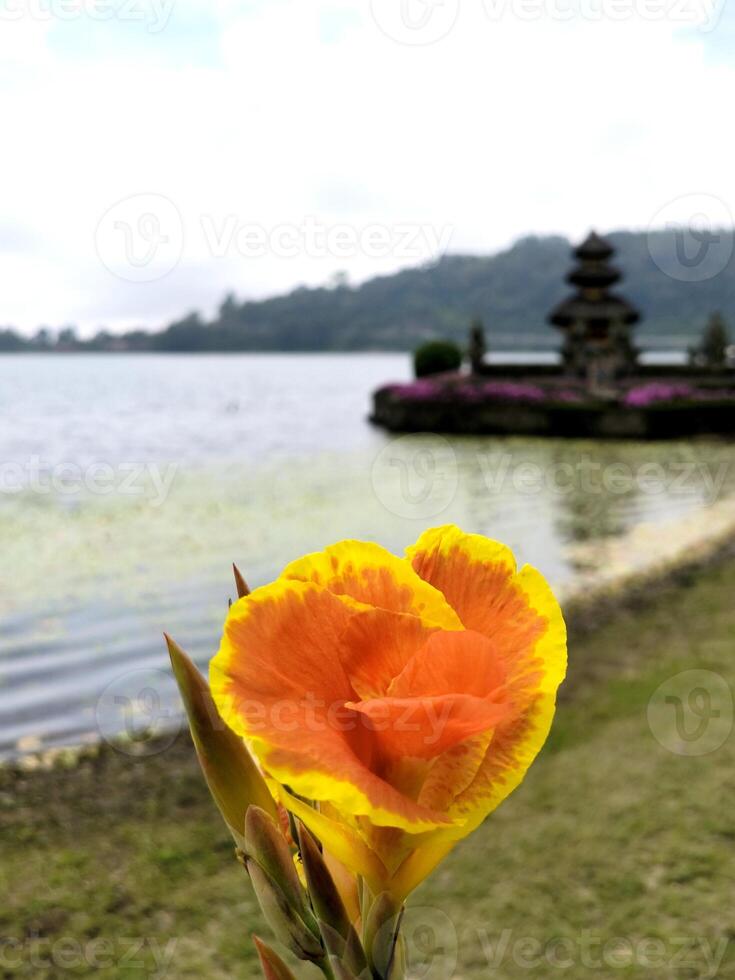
[0,354,735,757]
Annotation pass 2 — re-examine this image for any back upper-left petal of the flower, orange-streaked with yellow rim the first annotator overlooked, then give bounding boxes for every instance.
[282,541,462,629]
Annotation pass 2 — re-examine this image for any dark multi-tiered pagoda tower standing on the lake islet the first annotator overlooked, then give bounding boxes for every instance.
[549,231,640,393]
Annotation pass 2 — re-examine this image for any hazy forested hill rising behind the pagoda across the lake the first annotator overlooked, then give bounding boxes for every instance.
[5,231,735,351]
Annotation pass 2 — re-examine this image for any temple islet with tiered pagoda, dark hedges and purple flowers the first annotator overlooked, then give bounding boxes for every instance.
[371,232,735,439]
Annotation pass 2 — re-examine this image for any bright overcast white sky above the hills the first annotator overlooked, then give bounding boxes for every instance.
[0,0,735,334]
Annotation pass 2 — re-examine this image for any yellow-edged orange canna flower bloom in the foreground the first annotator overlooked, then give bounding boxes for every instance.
[211,526,566,901]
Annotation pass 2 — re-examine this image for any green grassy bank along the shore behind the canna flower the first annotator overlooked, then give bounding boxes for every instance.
[0,559,735,980]
